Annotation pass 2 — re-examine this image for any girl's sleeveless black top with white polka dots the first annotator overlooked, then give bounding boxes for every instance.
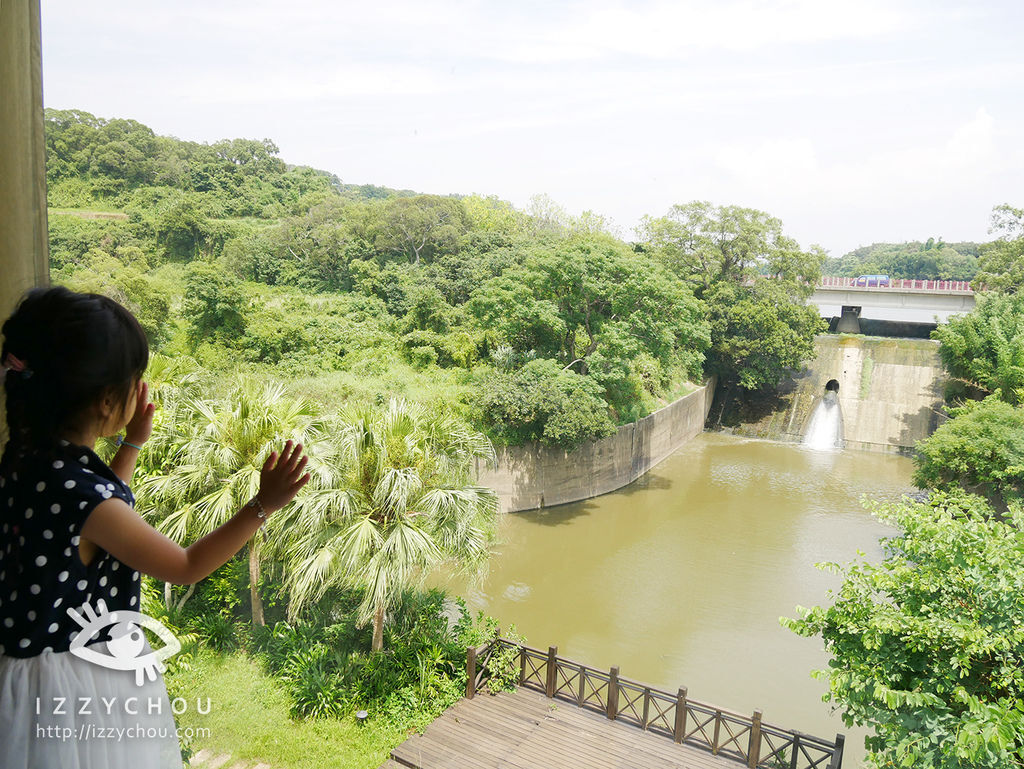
[0,441,139,657]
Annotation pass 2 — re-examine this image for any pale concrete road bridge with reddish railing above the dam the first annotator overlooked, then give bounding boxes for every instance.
[808,277,975,334]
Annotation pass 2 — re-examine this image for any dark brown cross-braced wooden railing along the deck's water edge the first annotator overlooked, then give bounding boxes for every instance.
[466,638,845,769]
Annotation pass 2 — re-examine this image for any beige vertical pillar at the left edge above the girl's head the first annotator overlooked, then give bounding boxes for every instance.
[0,0,49,438]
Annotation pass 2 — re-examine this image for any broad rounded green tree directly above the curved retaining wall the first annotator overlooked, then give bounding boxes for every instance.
[466,233,710,428]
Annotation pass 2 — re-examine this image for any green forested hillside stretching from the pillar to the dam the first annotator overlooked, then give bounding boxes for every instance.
[46,105,823,446]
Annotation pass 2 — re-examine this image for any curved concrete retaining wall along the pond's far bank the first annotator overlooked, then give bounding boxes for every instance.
[476,380,715,513]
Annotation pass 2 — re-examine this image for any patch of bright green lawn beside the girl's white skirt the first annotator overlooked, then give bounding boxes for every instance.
[171,650,407,769]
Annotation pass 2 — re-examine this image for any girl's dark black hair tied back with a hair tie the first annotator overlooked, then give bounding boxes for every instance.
[0,286,150,462]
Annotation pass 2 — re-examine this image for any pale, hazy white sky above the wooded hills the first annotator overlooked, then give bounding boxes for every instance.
[42,0,1024,256]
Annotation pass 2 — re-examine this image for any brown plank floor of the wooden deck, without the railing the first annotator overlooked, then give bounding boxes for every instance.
[381,687,743,769]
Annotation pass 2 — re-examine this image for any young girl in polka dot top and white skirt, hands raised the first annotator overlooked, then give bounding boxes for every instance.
[0,288,309,769]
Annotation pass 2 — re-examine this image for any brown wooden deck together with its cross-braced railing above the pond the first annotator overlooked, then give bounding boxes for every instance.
[380,638,845,769]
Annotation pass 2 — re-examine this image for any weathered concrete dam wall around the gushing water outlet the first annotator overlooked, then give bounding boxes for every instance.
[712,335,945,454]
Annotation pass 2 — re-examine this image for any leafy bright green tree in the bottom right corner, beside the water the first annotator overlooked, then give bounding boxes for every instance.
[782,495,1024,769]
